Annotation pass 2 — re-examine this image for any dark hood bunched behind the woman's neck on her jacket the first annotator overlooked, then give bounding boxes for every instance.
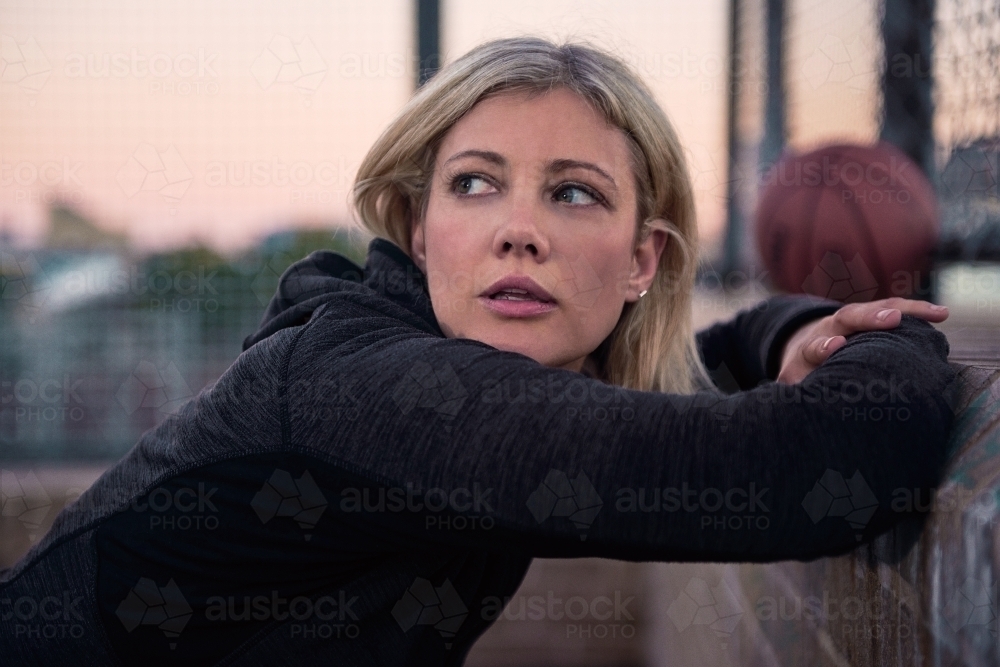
[243,238,443,350]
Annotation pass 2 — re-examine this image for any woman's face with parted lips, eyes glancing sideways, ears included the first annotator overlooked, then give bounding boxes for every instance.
[411,89,666,371]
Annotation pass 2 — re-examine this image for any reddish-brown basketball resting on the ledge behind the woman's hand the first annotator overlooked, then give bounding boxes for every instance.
[755,142,940,303]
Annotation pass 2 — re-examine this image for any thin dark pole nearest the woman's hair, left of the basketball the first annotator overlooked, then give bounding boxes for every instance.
[722,0,743,274]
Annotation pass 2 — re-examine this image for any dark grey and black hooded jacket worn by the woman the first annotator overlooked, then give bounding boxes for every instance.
[0,240,954,666]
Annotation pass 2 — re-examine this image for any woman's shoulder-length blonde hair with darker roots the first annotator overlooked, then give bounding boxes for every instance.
[354,37,713,394]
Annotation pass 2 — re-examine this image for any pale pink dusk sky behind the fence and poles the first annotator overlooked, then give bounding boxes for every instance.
[0,0,875,251]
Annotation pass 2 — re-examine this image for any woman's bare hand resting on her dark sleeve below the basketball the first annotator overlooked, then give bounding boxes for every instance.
[778,297,948,384]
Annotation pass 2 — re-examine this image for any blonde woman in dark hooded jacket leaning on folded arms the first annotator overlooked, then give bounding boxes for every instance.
[0,39,953,665]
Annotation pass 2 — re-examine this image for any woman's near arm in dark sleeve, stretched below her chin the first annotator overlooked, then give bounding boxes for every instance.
[285,295,954,561]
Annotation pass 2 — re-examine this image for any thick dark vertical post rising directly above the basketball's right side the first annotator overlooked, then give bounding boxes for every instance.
[879,0,935,180]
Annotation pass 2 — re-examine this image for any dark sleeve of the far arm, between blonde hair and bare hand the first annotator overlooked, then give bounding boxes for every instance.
[695,294,843,393]
